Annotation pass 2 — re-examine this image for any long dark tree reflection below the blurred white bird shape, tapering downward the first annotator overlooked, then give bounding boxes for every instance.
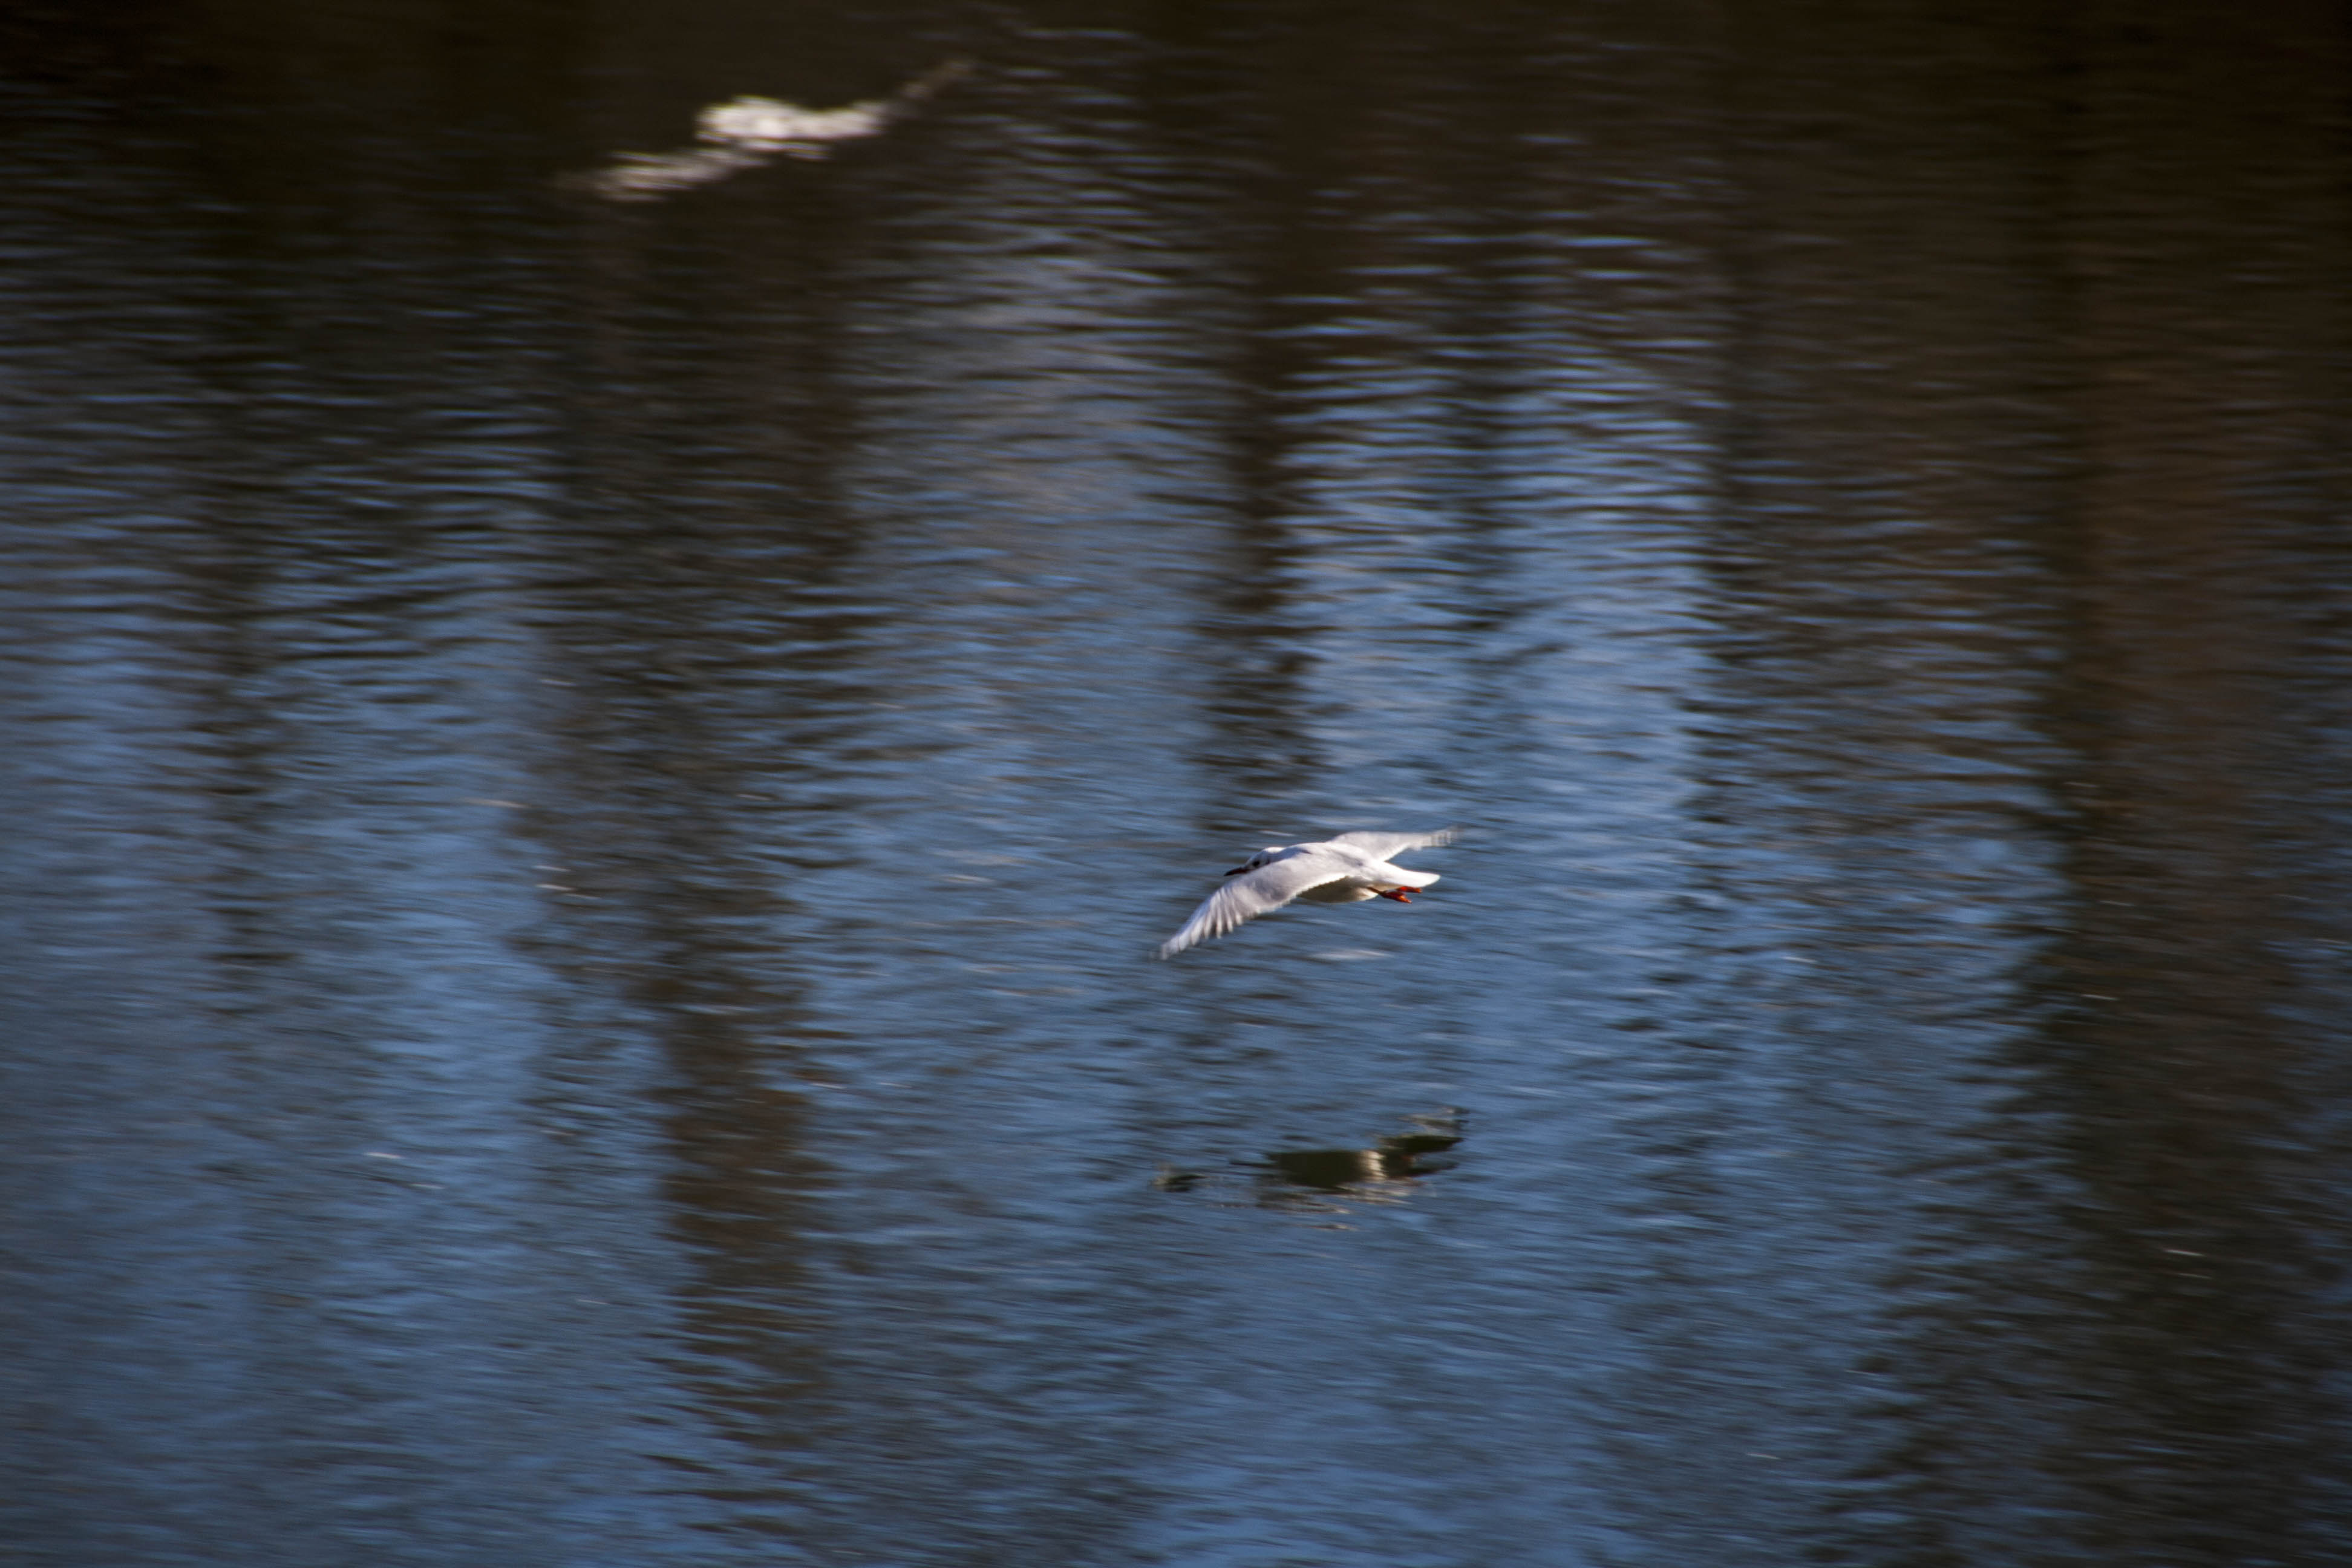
[520,183,882,1540]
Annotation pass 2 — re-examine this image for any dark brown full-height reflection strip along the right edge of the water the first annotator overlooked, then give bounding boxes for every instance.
[2034,7,2352,1563]
